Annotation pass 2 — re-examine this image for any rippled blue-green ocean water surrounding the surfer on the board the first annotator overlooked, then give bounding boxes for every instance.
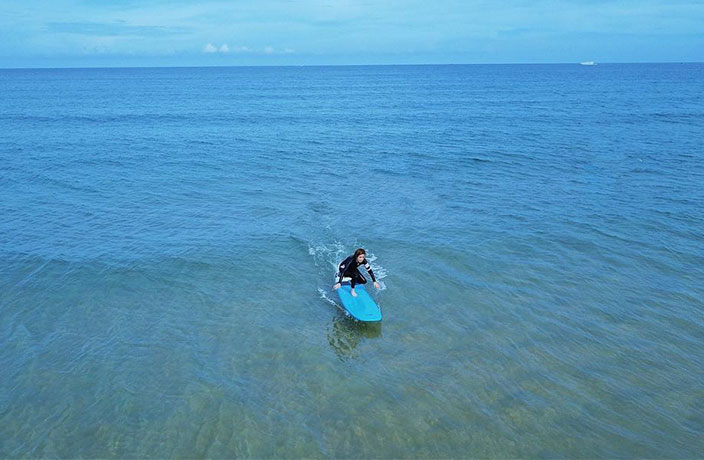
[0,64,704,458]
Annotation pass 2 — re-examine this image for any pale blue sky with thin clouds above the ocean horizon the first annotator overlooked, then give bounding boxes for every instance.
[0,0,704,68]
